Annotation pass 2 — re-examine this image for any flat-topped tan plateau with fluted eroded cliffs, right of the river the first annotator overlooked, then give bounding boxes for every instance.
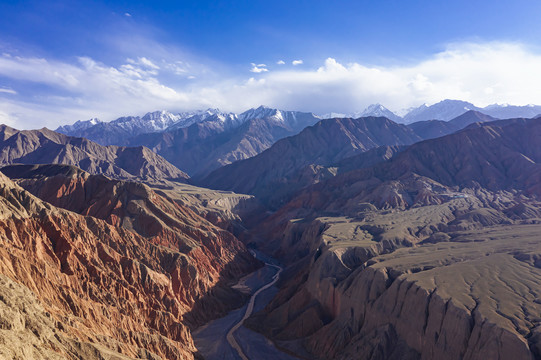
[249,197,541,359]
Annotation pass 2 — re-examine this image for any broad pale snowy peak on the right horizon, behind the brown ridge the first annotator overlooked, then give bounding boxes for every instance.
[398,99,483,124]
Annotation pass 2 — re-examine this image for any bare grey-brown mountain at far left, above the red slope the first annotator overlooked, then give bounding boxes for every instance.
[0,125,188,181]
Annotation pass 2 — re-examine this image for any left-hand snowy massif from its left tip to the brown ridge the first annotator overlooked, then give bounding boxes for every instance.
[58,106,319,177]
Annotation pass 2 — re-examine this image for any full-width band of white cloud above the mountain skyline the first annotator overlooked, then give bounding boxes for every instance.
[0,42,541,128]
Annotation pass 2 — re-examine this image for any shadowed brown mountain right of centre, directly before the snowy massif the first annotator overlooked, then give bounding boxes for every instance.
[201,117,420,204]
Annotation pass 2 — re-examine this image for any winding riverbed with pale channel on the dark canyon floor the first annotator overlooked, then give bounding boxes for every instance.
[193,253,298,360]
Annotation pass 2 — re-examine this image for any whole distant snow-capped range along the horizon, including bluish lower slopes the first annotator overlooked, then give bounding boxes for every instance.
[52,100,541,179]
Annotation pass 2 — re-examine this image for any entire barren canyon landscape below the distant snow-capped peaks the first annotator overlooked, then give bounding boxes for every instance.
[0,109,541,360]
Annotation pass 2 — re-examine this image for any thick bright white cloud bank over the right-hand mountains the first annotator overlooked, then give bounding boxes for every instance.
[228,42,541,113]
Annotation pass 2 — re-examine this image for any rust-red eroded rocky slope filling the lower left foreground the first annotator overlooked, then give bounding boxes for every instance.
[0,165,257,359]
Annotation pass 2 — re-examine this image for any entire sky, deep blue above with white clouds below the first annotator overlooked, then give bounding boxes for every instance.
[0,0,541,128]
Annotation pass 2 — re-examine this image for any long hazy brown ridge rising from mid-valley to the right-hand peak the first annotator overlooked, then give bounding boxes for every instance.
[199,110,495,208]
